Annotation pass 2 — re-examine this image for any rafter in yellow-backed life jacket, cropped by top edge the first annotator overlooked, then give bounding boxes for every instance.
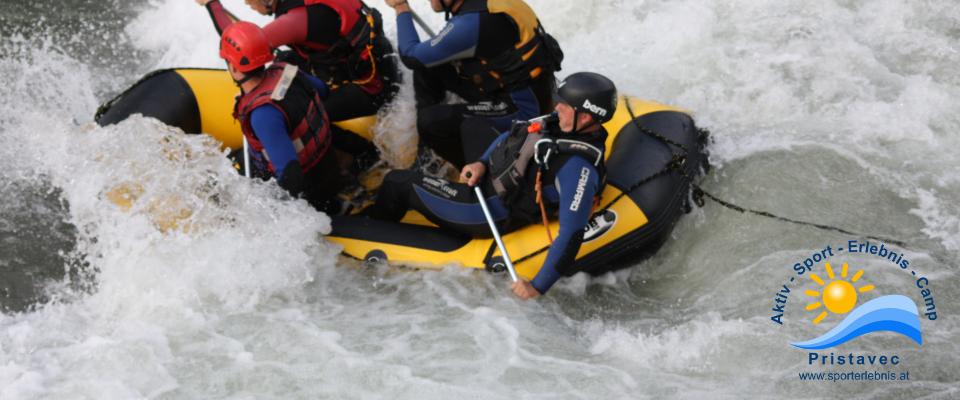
[397,0,562,167]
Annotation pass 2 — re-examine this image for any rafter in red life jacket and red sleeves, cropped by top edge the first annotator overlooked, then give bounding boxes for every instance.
[196,0,399,172]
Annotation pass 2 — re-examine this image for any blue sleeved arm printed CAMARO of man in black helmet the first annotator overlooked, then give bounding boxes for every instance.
[530,157,600,294]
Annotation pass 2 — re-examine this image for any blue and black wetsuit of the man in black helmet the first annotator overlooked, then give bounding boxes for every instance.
[365,122,606,293]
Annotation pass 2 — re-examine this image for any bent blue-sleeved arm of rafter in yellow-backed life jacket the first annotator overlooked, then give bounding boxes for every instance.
[397,12,480,69]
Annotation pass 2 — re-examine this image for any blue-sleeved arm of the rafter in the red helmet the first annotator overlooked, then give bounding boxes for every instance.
[250,105,303,194]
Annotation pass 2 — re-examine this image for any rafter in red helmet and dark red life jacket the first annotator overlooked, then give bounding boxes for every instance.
[220,21,342,214]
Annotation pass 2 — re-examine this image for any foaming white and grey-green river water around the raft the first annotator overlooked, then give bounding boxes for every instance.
[0,0,960,399]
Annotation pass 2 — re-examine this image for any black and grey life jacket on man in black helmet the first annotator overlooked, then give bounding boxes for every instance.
[487,117,607,226]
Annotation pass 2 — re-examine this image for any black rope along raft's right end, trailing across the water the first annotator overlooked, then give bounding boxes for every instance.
[513,98,908,264]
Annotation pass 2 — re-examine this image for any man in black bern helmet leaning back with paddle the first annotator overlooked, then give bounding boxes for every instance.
[365,72,617,299]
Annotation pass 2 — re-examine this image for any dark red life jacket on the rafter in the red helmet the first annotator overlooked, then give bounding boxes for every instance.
[233,63,331,173]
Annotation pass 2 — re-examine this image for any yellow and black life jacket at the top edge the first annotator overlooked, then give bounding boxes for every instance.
[457,0,563,94]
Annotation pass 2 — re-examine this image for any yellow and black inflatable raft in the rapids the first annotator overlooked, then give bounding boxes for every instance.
[97,69,708,279]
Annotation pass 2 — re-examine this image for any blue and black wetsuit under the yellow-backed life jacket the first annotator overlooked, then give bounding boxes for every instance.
[397,1,554,167]
